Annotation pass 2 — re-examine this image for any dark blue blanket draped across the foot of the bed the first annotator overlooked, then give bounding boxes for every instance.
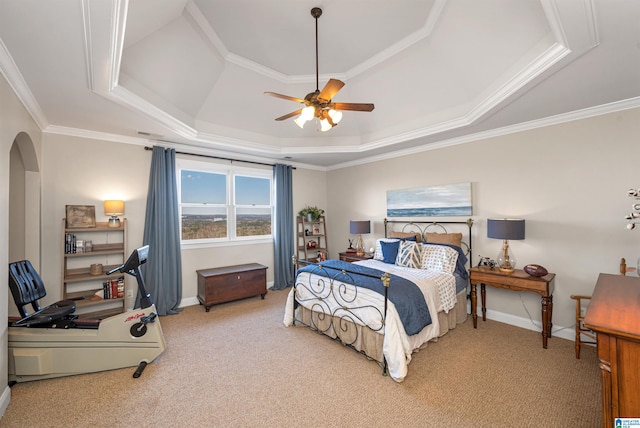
[298,260,431,336]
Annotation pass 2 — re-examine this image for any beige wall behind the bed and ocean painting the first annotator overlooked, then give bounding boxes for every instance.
[327,109,640,338]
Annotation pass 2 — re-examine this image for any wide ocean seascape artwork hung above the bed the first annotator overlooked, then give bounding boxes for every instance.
[387,183,472,217]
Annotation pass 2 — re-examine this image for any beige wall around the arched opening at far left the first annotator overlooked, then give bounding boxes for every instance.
[0,75,41,415]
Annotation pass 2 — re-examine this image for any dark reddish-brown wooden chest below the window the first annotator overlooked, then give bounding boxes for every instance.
[196,263,267,312]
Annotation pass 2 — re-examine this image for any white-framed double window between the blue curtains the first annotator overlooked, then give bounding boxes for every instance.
[178,160,273,243]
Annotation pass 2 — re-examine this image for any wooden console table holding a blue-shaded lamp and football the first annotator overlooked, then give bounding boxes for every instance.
[469,266,556,349]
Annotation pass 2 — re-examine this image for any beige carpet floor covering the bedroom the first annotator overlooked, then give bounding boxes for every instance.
[0,291,602,427]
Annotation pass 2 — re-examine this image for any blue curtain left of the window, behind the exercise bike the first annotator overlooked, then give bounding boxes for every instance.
[136,146,182,315]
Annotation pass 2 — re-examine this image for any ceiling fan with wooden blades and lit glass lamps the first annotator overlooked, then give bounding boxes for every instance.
[265,7,374,131]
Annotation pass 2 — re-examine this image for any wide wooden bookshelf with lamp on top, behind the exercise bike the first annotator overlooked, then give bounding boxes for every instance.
[62,219,127,318]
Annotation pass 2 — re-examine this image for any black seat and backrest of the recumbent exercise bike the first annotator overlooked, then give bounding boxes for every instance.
[9,260,76,327]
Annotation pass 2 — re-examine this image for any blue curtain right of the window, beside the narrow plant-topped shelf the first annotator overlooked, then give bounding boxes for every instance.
[271,164,295,290]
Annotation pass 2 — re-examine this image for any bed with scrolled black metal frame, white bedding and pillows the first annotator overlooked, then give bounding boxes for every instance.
[284,219,473,382]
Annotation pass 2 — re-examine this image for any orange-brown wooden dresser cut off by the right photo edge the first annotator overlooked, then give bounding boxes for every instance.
[584,273,640,427]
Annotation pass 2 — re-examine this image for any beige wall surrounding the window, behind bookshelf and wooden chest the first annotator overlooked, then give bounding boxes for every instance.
[41,134,326,307]
